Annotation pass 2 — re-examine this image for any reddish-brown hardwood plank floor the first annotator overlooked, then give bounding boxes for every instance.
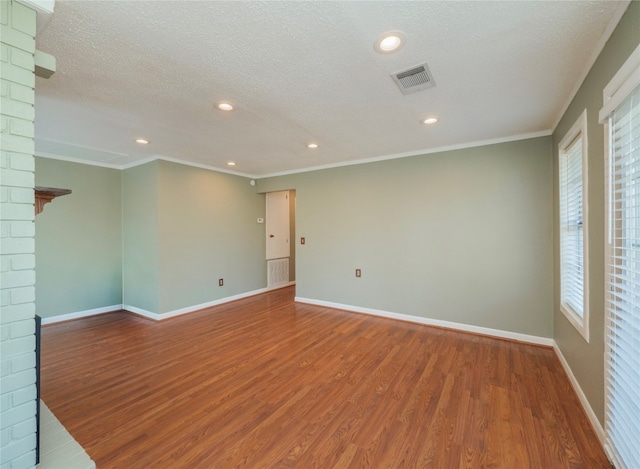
[42,288,611,469]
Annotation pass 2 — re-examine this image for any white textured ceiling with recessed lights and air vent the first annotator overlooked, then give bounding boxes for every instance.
[36,0,628,177]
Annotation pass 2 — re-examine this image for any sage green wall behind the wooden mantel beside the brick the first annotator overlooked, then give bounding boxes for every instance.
[35,158,122,318]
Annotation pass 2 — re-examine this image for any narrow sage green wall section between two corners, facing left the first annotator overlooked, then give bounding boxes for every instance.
[122,161,160,313]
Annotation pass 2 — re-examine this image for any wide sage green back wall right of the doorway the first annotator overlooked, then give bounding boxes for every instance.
[257,137,553,337]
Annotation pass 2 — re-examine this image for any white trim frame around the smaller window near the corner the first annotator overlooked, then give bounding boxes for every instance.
[558,109,589,342]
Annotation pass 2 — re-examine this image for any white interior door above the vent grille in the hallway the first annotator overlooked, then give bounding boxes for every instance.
[266,191,291,260]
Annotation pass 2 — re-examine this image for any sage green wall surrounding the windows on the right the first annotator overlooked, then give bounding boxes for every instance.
[553,1,640,424]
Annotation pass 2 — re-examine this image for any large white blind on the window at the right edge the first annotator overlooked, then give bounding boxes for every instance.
[605,86,640,469]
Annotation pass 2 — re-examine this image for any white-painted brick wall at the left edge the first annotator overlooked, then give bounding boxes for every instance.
[0,0,36,469]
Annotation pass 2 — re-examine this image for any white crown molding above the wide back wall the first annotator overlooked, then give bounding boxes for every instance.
[253,129,553,179]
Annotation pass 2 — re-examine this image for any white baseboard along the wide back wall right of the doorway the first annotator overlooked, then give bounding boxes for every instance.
[295,296,555,347]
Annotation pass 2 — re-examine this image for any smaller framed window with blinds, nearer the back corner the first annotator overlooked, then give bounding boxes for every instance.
[558,111,589,341]
